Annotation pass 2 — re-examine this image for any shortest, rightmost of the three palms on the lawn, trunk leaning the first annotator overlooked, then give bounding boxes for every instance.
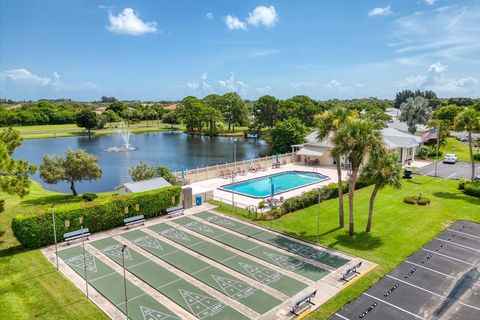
[360,150,402,232]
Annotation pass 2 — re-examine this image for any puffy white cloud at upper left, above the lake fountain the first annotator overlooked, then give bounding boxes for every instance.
[107,8,158,36]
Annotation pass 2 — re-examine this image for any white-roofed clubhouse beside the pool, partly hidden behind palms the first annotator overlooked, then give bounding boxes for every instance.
[292,128,421,165]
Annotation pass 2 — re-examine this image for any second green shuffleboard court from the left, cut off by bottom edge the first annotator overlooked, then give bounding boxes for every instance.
[91,238,248,320]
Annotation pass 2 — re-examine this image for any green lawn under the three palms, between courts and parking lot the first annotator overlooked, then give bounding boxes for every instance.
[212,176,480,319]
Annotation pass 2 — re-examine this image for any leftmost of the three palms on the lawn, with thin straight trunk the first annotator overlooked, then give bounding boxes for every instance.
[315,108,349,228]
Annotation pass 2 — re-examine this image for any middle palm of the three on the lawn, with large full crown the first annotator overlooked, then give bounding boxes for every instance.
[332,119,382,236]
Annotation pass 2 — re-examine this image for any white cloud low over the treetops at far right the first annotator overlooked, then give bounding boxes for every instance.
[399,62,478,94]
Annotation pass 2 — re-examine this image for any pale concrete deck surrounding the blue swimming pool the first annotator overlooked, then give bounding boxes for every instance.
[191,162,347,206]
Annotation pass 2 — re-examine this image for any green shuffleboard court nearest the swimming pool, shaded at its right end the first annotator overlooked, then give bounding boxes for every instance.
[195,211,350,269]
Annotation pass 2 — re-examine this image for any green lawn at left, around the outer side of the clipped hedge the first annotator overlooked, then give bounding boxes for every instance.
[0,182,109,320]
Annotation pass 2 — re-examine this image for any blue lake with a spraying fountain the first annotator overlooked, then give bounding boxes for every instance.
[14,131,269,193]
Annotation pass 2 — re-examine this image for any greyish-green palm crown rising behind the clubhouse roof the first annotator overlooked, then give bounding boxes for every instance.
[398,96,432,134]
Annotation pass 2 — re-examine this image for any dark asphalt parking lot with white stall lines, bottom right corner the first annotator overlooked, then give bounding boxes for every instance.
[330,221,480,320]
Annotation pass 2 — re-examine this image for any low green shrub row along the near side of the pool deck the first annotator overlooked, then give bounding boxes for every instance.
[262,180,368,219]
